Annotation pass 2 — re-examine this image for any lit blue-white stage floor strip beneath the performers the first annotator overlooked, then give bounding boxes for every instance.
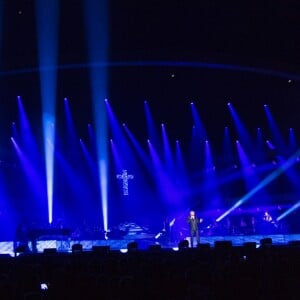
[0,234,300,256]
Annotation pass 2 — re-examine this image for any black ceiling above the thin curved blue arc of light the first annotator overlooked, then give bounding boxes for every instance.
[2,0,300,72]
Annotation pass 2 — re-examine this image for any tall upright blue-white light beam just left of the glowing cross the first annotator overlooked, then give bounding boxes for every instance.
[84,0,109,231]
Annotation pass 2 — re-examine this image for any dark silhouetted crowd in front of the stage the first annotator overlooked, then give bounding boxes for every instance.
[0,242,300,300]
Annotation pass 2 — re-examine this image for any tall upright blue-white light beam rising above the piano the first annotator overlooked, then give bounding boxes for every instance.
[35,0,59,224]
